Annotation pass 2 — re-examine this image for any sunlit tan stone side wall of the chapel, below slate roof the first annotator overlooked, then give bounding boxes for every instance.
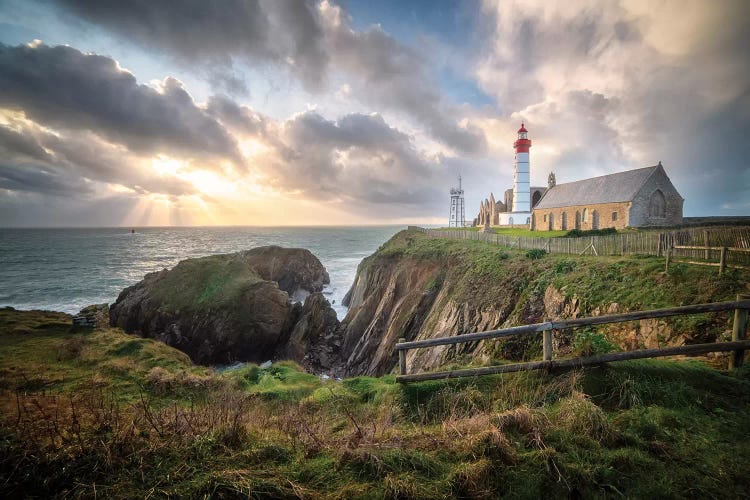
[533,202,631,231]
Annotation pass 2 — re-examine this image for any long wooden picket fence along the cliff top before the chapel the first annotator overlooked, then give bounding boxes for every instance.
[418,226,750,265]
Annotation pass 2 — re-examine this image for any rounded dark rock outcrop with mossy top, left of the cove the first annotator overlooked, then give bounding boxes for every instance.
[110,247,346,369]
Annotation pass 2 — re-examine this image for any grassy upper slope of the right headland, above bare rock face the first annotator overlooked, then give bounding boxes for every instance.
[370,231,750,356]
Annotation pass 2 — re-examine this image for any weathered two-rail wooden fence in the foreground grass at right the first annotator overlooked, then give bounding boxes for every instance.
[395,295,750,382]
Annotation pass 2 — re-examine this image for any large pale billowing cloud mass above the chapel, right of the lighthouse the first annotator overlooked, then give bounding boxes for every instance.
[475,0,750,215]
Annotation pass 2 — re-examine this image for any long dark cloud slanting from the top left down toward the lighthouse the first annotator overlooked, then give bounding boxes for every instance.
[54,0,486,154]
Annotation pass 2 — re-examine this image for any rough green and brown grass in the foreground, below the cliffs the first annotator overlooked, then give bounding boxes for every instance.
[0,310,750,498]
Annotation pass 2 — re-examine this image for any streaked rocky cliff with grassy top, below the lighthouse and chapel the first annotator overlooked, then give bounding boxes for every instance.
[340,231,748,375]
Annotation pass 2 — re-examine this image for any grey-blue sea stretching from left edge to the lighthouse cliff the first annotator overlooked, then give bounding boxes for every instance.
[0,226,404,318]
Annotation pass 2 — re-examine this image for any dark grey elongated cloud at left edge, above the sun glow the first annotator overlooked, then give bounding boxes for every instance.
[0,44,241,164]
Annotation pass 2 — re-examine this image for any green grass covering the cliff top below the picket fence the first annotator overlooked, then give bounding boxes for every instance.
[372,231,750,359]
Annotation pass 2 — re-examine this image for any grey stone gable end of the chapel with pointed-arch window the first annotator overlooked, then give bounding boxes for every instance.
[630,168,684,227]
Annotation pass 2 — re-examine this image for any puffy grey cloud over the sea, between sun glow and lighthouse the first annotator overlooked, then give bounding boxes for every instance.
[268,112,443,207]
